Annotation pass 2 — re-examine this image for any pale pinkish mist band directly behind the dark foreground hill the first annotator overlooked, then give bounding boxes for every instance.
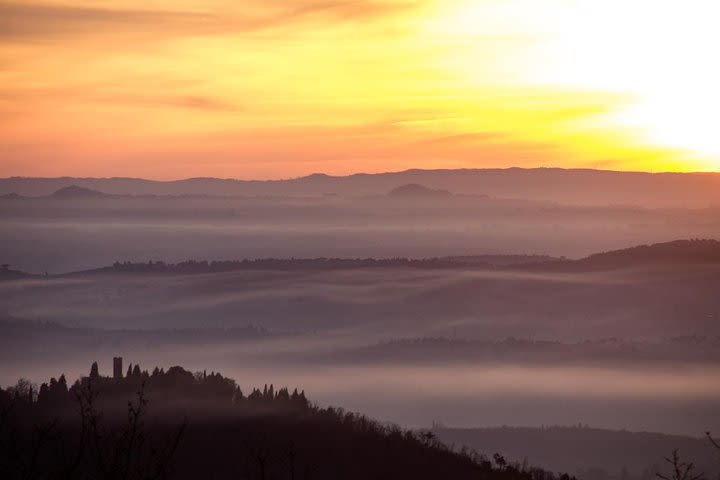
[0,345,720,438]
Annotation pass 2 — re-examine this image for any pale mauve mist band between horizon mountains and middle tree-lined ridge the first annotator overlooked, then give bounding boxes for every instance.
[0,189,720,273]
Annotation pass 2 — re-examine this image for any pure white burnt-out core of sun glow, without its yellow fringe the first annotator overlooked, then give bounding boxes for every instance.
[550,0,720,164]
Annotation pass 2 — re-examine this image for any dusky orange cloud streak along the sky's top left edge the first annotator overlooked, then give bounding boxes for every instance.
[0,0,413,41]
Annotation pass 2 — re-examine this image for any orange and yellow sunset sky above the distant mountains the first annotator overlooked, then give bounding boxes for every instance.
[0,0,720,179]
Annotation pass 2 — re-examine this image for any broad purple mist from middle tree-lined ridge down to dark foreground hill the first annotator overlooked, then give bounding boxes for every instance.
[0,265,720,436]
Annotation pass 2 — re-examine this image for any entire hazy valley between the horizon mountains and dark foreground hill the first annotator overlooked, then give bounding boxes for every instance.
[0,171,720,480]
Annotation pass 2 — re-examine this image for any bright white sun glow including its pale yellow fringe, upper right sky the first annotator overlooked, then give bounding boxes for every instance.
[430,0,720,169]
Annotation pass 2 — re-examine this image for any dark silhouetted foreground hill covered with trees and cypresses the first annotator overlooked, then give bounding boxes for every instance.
[0,364,570,480]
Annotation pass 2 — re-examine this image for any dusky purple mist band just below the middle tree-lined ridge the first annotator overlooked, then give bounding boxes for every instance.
[0,266,720,343]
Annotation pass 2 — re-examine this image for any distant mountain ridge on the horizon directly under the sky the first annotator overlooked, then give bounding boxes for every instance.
[5,168,720,208]
